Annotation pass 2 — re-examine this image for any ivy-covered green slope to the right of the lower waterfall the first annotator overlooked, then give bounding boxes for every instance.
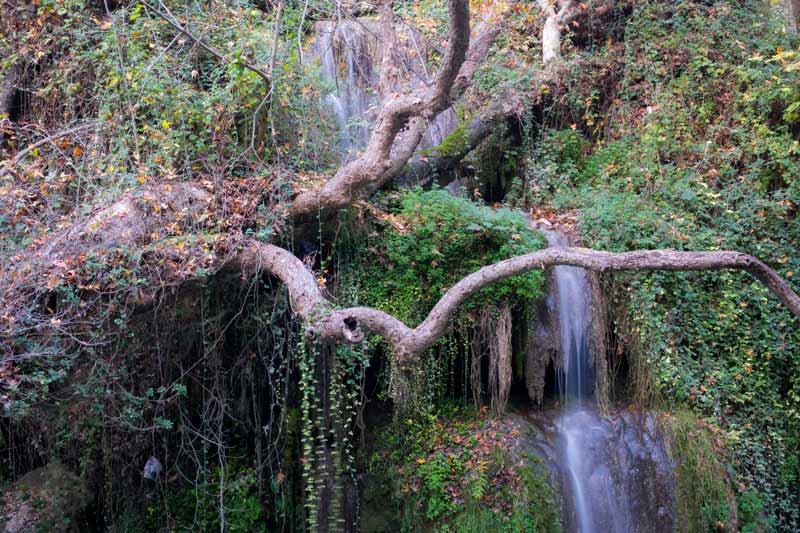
[516,0,800,530]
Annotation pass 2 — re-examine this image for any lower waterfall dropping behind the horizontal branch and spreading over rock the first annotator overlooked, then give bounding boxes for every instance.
[545,231,673,533]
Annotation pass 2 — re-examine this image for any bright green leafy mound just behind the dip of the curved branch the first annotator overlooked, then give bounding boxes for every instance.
[358,189,544,323]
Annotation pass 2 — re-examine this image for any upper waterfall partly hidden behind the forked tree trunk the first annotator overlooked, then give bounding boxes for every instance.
[313,17,457,161]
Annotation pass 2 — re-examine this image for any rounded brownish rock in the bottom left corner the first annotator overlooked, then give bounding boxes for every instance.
[0,463,91,533]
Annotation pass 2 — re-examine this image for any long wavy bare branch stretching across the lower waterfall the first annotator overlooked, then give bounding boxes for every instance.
[240,243,800,361]
